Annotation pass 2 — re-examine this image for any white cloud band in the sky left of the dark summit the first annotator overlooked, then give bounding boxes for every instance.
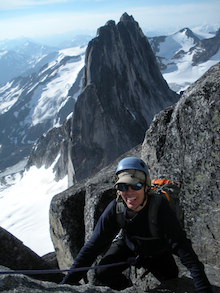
[0,12,114,40]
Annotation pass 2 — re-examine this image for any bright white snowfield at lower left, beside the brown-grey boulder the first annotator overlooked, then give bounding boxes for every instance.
[0,157,68,256]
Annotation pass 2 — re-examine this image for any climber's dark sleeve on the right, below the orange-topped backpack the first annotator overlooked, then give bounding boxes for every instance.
[158,199,213,293]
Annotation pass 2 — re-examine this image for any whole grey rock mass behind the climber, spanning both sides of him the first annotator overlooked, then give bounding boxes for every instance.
[50,64,220,290]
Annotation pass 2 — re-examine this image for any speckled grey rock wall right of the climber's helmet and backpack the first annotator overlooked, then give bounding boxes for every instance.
[142,63,220,265]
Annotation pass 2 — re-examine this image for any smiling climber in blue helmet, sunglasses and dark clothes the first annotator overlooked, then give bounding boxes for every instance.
[61,157,213,293]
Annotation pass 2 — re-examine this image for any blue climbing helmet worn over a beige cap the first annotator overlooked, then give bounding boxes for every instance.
[115,157,151,187]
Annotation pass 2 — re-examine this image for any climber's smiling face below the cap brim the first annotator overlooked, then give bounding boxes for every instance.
[120,185,148,212]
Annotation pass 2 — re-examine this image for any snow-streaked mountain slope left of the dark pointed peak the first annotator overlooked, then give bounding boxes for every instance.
[0,47,86,170]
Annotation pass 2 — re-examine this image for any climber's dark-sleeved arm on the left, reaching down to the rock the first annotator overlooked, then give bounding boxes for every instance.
[61,200,120,285]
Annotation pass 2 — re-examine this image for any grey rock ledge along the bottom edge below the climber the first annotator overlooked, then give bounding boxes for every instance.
[0,266,220,293]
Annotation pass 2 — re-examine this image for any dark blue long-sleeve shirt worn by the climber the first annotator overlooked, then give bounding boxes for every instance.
[62,193,213,293]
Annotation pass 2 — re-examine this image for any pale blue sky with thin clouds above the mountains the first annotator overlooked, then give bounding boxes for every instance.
[0,0,220,40]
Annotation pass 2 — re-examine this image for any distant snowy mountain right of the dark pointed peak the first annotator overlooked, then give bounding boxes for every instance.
[149,28,220,92]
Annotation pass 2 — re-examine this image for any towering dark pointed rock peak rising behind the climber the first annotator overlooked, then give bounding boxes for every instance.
[29,13,179,185]
